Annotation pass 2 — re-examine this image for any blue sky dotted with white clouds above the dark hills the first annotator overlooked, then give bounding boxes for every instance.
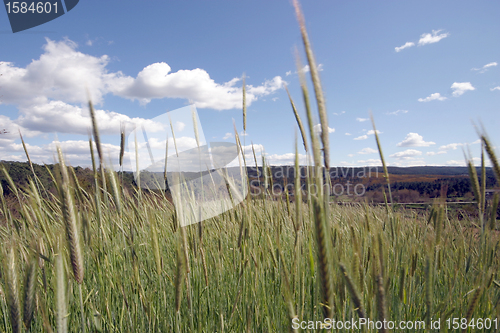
[0,0,500,166]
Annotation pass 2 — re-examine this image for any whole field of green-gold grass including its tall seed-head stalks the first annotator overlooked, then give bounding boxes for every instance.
[0,4,500,332]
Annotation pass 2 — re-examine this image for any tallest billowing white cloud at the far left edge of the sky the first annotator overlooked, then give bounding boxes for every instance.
[0,39,111,105]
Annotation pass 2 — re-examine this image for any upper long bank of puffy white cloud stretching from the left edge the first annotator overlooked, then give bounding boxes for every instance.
[0,39,283,110]
